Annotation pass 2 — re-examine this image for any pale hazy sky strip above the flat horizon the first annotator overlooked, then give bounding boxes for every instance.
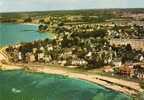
[0,0,144,12]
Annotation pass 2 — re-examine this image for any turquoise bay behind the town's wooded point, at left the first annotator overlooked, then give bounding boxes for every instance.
[0,23,52,47]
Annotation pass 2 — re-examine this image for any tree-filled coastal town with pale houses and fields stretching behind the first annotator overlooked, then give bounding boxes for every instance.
[0,9,144,97]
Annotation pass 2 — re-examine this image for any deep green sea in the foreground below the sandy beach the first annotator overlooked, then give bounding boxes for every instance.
[0,71,130,100]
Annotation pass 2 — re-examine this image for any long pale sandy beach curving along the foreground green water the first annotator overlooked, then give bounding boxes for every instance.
[1,64,143,96]
